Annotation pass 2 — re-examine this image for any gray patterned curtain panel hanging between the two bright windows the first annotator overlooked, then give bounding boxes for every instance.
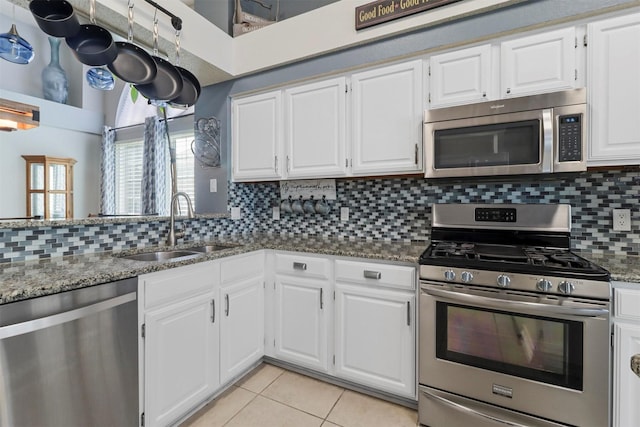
[141,117,169,216]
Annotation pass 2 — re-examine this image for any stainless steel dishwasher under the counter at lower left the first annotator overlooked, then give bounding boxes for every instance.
[0,278,139,427]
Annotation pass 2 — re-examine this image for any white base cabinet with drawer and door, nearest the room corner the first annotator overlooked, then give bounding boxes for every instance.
[274,254,332,372]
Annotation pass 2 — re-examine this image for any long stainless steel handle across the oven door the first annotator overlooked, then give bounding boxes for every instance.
[422,288,609,317]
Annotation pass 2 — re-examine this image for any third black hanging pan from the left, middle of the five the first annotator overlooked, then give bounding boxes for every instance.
[107,0,158,84]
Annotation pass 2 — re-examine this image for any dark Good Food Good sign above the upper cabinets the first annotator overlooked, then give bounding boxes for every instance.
[356,0,461,30]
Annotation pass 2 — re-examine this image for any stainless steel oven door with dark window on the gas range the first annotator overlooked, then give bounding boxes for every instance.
[419,282,610,427]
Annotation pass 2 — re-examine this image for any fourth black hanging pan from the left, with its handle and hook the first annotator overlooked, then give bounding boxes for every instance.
[135,9,184,101]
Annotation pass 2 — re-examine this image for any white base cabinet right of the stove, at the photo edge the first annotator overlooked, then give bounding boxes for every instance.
[613,283,640,427]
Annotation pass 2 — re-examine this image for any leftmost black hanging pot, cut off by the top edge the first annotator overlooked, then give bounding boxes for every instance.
[29,0,80,37]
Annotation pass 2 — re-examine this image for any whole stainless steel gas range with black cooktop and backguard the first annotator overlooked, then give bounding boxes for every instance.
[418,204,611,427]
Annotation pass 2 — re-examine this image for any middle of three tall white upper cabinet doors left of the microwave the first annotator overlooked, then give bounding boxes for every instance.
[284,77,347,179]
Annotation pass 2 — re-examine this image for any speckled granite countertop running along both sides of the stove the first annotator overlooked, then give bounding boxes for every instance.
[0,235,640,304]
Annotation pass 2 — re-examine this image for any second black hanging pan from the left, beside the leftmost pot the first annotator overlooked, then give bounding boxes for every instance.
[66,0,118,66]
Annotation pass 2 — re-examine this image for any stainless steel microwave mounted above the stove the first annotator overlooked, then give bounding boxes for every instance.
[424,88,588,178]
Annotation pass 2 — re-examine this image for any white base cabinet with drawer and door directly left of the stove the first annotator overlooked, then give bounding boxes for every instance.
[334,261,416,398]
